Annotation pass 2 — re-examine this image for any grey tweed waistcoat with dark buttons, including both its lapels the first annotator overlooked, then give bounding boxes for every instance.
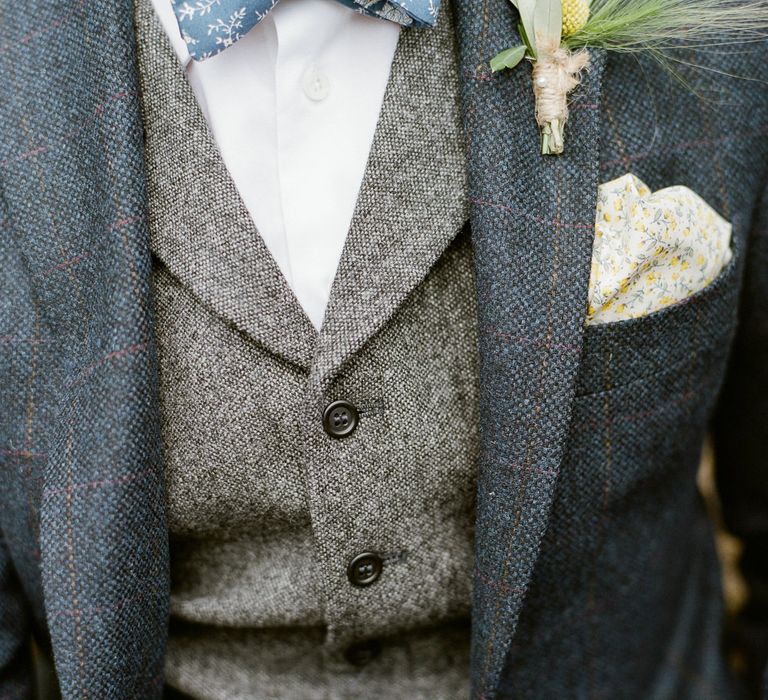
[137,0,477,700]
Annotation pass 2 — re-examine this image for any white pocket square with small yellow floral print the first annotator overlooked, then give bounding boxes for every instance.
[587,174,732,324]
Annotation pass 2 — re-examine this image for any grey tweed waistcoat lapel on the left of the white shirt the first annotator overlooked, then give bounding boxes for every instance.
[137,2,317,369]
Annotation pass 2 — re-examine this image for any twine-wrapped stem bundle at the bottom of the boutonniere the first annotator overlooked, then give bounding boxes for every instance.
[533,47,589,155]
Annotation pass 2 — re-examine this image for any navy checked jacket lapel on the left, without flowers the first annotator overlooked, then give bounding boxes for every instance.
[0,0,169,698]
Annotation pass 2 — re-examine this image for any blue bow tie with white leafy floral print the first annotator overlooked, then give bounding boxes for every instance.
[171,0,440,61]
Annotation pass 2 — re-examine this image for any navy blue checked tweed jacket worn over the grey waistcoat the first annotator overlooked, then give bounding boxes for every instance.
[0,0,768,700]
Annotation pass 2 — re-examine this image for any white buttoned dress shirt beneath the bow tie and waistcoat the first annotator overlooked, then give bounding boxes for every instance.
[153,0,400,329]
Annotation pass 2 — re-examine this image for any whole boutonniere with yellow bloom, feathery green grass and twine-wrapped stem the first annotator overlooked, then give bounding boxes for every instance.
[491,0,768,155]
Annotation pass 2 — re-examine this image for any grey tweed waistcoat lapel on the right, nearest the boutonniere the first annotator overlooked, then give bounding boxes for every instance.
[313,3,469,382]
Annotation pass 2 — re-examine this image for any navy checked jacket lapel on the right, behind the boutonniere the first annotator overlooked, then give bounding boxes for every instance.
[450,0,604,699]
